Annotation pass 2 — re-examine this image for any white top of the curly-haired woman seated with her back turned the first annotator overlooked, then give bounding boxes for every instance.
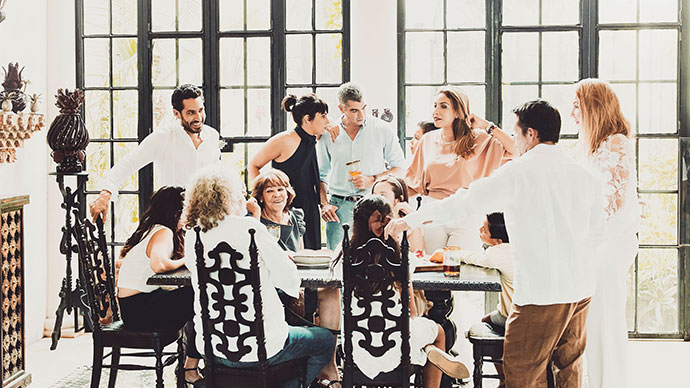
[184,216,301,362]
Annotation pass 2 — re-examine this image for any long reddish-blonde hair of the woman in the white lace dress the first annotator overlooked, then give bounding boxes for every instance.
[575,78,631,154]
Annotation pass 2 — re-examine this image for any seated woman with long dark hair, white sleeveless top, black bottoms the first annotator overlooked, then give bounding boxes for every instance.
[117,186,201,383]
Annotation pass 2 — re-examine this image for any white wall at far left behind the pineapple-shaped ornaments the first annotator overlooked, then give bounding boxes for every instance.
[0,0,49,343]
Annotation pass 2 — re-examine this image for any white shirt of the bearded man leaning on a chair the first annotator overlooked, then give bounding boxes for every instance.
[101,121,220,201]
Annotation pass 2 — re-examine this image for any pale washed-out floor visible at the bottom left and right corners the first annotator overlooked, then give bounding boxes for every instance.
[27,334,690,388]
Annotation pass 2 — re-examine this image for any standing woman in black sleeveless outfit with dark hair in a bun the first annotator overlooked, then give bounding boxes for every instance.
[247,94,328,249]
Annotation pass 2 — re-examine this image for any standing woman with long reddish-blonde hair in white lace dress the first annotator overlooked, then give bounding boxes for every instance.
[571,79,640,388]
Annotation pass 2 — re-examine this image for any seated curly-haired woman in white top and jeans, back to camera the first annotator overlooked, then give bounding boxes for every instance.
[184,166,335,387]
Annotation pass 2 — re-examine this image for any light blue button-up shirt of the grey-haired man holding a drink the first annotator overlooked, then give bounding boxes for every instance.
[316,117,405,196]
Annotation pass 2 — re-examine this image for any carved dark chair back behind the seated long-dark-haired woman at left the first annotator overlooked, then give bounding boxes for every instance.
[72,214,120,330]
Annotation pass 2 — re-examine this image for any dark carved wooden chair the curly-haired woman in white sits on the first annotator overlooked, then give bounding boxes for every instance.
[189,227,307,388]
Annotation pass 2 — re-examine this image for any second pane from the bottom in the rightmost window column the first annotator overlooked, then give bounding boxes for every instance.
[639,194,678,245]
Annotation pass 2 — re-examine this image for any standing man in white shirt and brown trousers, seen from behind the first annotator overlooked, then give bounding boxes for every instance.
[386,100,604,388]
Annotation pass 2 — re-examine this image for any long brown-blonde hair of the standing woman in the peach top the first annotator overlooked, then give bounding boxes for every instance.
[437,86,477,158]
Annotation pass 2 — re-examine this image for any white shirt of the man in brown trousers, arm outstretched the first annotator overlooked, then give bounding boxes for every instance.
[404,144,605,306]
